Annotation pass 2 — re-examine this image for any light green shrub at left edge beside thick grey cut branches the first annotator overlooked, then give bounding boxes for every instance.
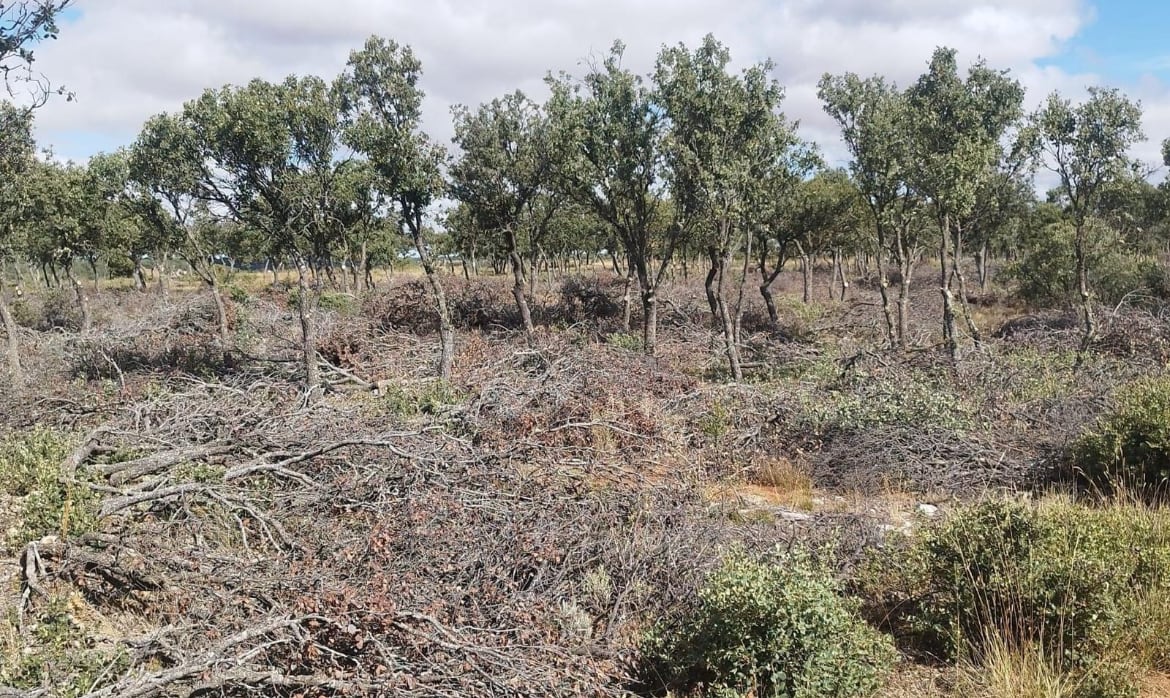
[0,428,97,547]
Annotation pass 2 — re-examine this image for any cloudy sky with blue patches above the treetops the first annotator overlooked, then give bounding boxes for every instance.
[20,0,1170,174]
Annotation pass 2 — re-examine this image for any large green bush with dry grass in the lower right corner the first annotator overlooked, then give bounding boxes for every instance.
[867,502,1170,696]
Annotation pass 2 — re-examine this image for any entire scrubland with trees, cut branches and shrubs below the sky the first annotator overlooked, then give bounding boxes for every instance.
[0,2,1170,698]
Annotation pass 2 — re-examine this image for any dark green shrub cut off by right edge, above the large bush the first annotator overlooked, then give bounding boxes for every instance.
[1071,375,1170,486]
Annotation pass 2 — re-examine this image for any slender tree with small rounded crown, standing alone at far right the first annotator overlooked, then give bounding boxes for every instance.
[1032,88,1145,358]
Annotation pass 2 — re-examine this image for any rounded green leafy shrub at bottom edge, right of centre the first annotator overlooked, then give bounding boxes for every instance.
[641,554,894,698]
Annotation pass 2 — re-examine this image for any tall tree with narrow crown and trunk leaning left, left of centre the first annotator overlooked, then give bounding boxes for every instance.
[338,36,455,379]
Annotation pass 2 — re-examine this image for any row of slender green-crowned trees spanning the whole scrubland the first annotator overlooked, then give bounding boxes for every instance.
[0,2,1170,386]
